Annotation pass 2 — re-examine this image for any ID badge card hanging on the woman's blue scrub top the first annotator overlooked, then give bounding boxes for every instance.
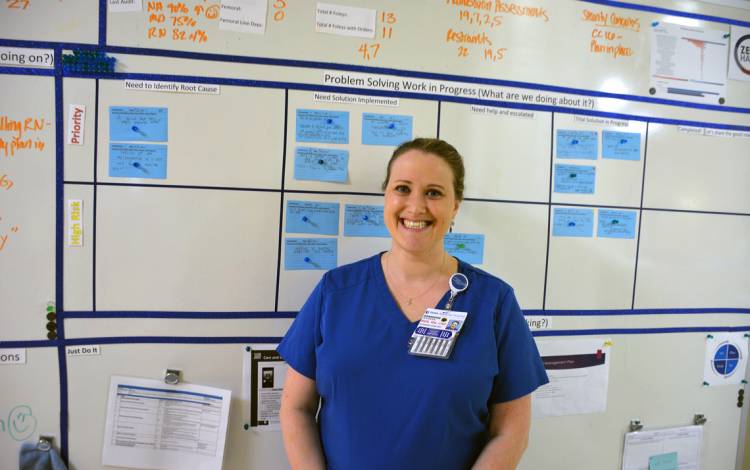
[409,308,468,359]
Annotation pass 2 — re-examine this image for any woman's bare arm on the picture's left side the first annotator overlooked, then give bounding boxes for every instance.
[279,367,326,470]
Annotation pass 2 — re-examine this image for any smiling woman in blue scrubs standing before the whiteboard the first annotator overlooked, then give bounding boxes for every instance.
[278,138,547,470]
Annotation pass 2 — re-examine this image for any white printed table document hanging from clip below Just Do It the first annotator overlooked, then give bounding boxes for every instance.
[102,376,232,470]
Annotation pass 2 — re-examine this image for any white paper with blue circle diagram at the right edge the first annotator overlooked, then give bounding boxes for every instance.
[703,333,747,386]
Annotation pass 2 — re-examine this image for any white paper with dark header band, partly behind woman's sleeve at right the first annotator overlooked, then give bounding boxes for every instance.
[531,338,611,418]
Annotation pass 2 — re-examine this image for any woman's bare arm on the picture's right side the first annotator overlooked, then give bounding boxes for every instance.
[473,394,531,470]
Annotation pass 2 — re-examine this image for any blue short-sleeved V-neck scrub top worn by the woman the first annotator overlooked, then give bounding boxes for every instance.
[278,255,548,470]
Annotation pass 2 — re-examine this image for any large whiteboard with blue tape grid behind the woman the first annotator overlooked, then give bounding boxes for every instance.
[0,0,750,469]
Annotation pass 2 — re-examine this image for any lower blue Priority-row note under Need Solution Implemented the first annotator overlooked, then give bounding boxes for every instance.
[294,147,349,183]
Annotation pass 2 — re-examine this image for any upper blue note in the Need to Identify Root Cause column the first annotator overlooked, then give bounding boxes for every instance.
[109,106,168,142]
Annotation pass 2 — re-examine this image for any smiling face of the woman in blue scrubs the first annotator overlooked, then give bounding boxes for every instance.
[383,150,459,256]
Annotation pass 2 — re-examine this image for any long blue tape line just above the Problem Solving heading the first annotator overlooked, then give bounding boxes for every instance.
[0,33,750,114]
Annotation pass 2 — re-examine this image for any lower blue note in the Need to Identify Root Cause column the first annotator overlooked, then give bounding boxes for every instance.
[109,143,167,179]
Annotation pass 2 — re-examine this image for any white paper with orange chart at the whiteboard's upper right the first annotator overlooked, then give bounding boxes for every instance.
[651,23,729,104]
